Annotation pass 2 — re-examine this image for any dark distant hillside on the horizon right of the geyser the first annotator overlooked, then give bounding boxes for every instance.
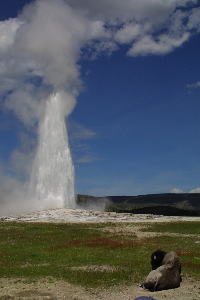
[77,193,200,216]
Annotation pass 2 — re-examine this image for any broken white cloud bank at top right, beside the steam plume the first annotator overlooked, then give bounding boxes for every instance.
[68,0,200,56]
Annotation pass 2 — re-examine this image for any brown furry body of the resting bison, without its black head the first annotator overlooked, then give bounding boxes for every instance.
[142,251,181,291]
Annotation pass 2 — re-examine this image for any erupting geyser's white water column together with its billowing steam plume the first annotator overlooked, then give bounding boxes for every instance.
[0,0,88,214]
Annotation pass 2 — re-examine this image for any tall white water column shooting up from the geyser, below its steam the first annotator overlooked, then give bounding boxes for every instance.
[31,93,76,209]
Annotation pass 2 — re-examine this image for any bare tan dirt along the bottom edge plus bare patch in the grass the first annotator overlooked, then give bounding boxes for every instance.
[0,212,200,300]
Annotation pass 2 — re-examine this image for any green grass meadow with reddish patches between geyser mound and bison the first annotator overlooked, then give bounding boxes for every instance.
[0,222,200,287]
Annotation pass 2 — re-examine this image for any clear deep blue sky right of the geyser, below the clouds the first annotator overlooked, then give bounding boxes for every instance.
[71,36,200,195]
